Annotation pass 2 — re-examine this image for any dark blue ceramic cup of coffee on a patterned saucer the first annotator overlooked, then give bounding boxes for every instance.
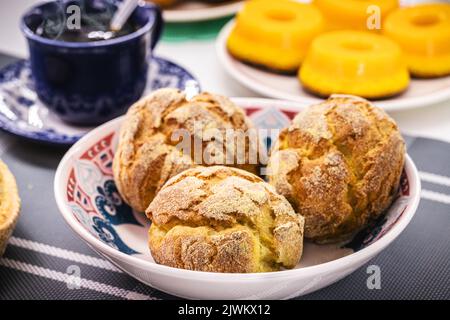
[21,0,163,125]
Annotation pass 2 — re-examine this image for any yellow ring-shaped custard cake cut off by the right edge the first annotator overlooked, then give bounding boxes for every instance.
[383,3,450,78]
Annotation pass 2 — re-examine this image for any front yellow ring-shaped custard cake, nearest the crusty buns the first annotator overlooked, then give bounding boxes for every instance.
[299,31,409,99]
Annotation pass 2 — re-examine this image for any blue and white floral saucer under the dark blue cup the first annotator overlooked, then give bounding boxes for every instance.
[0,57,197,145]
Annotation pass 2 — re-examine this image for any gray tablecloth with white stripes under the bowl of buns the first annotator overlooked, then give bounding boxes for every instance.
[0,56,450,300]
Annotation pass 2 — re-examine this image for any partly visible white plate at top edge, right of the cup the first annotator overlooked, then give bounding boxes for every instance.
[163,1,244,22]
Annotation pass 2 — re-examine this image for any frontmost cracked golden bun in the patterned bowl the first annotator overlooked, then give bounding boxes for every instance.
[146,166,304,273]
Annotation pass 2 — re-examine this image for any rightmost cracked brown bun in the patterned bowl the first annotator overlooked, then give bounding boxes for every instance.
[268,95,405,243]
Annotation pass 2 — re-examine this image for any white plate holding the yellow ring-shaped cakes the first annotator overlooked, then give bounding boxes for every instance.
[216,20,450,111]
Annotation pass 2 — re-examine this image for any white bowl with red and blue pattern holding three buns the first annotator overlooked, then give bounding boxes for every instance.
[54,98,420,299]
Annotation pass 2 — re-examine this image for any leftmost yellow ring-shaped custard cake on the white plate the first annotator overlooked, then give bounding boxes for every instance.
[227,0,324,73]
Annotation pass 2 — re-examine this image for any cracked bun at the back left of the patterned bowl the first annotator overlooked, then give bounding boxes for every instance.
[113,89,258,212]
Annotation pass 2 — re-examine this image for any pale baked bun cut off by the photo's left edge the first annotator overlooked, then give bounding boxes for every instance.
[0,160,20,256]
